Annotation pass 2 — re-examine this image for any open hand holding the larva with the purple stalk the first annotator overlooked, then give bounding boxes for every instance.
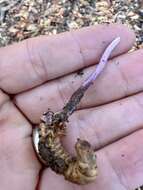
[0,25,143,190]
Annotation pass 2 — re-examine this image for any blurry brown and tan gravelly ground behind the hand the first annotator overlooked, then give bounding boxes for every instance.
[0,0,143,190]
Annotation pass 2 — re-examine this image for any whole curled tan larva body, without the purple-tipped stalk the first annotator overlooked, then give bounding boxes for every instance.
[33,111,97,184]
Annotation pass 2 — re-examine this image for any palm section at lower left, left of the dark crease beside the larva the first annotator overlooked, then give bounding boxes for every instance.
[0,92,40,190]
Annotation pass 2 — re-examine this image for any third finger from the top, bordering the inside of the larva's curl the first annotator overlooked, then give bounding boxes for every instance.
[63,93,143,152]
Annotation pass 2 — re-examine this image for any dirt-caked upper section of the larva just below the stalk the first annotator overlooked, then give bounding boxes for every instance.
[38,123,71,174]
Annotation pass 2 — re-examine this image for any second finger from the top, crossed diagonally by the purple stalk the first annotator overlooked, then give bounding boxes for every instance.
[15,50,143,122]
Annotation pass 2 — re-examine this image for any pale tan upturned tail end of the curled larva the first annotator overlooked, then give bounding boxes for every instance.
[64,139,97,184]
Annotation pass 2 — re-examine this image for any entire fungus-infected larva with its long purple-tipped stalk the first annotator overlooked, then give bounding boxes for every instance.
[33,37,120,184]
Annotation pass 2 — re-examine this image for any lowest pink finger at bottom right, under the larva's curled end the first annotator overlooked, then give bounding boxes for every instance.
[40,130,143,190]
